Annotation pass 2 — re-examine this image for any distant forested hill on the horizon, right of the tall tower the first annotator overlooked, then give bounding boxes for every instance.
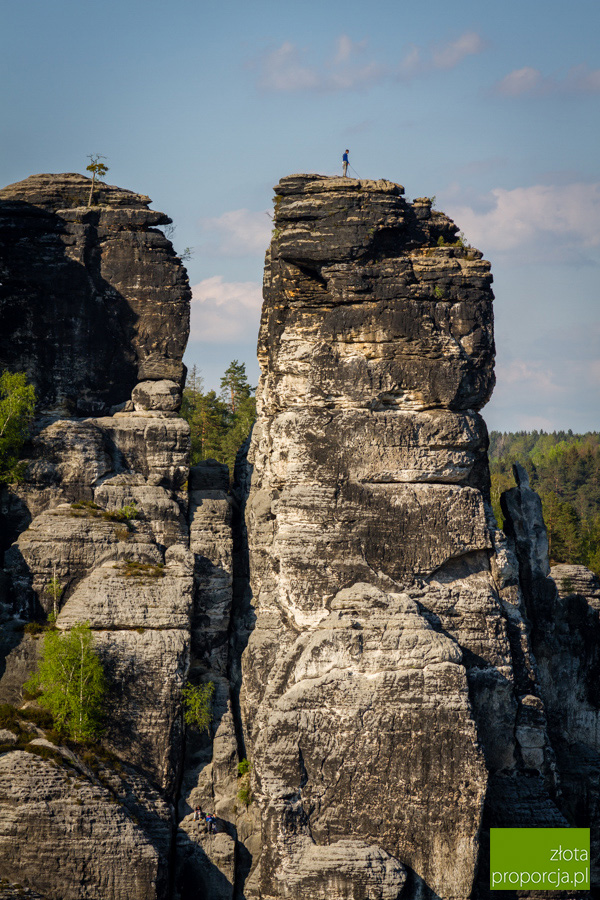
[489,431,600,575]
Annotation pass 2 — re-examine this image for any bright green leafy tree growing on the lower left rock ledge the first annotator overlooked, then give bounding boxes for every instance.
[25,623,107,741]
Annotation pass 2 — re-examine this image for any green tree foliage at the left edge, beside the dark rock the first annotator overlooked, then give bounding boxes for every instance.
[0,371,35,484]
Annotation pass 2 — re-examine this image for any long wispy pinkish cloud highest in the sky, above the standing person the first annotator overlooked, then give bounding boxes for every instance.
[257,31,485,92]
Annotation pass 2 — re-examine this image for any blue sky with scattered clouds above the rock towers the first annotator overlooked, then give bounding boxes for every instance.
[0,0,600,431]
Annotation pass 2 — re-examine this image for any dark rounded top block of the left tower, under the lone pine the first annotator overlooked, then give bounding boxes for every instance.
[0,174,190,415]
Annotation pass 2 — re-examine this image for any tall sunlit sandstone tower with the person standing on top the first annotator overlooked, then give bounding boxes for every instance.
[240,175,562,900]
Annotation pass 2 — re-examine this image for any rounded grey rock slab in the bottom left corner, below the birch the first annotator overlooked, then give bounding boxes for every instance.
[0,742,170,900]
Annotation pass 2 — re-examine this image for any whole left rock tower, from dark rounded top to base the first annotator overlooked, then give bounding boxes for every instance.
[0,175,194,900]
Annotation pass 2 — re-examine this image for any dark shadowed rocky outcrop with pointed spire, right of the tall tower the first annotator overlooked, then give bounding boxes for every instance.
[501,464,600,883]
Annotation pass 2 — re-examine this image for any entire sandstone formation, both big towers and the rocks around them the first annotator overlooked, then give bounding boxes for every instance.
[0,175,600,900]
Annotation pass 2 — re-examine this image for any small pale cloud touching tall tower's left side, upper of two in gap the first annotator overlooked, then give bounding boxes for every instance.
[200,209,273,256]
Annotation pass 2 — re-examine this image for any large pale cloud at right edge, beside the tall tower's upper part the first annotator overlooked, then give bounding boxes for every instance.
[449,182,600,262]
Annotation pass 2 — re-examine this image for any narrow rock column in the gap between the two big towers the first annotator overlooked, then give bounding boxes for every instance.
[175,460,239,900]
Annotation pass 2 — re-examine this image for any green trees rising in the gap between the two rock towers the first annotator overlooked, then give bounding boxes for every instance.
[181,359,256,473]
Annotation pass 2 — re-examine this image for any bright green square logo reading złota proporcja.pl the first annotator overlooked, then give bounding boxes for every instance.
[490,828,590,891]
